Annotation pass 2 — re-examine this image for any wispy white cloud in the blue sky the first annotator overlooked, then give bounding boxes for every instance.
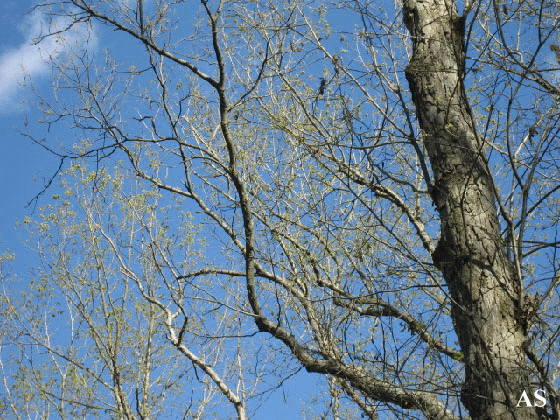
[0,11,95,113]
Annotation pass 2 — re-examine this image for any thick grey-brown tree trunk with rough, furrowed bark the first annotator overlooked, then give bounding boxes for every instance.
[403,0,539,419]
